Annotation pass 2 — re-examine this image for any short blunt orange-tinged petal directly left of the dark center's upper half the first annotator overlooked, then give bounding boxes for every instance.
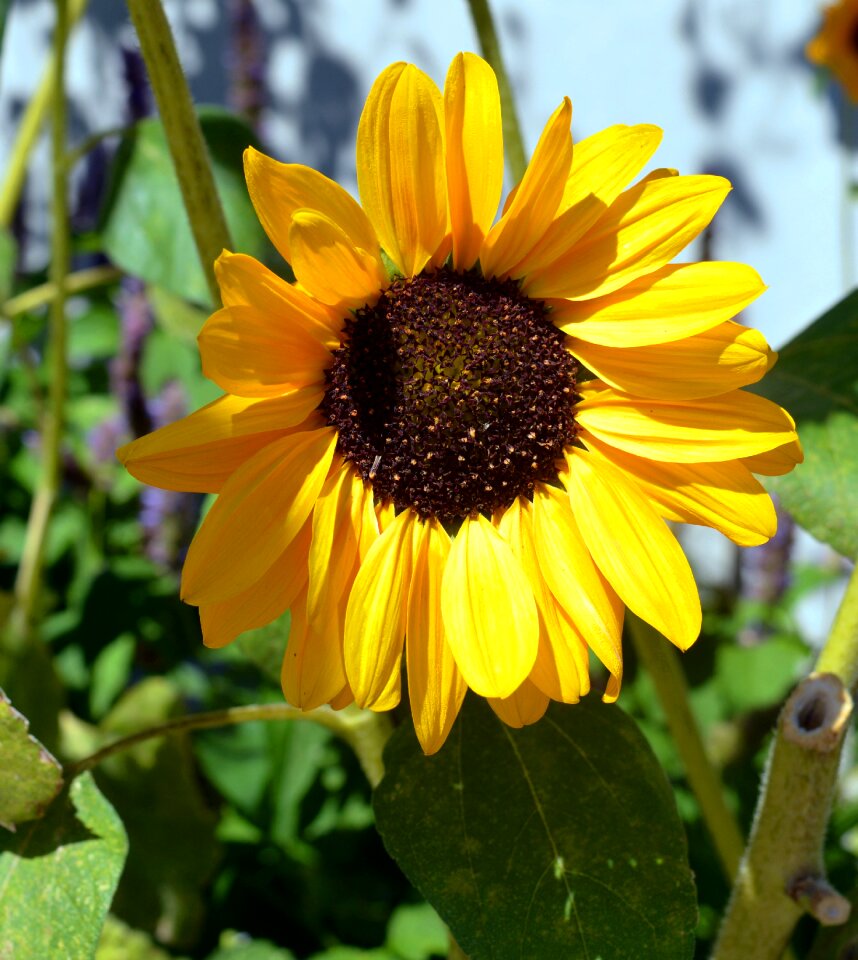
[197,306,331,397]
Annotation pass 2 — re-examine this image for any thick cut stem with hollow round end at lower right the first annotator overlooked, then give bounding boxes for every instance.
[712,567,858,960]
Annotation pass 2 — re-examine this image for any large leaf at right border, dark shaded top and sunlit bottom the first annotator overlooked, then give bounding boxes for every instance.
[751,292,858,557]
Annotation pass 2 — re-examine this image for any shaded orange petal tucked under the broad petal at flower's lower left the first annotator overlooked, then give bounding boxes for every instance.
[200,520,311,647]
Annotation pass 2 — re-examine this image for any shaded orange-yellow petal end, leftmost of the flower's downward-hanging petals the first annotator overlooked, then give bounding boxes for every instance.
[280,591,346,710]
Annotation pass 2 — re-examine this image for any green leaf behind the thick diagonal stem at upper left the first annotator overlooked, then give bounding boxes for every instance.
[101,107,270,306]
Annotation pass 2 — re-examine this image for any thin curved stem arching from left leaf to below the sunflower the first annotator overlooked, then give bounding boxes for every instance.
[66,703,392,788]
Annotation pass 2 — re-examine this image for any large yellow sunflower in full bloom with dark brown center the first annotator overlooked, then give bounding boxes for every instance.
[119,53,801,753]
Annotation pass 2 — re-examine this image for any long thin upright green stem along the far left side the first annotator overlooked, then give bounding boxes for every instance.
[8,0,70,652]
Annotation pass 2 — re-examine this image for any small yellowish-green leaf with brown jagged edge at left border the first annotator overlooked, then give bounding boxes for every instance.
[0,690,63,830]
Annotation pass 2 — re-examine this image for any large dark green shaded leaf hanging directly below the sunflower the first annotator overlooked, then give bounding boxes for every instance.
[375,697,697,960]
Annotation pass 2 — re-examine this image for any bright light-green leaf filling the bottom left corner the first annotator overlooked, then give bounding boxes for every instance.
[0,773,128,960]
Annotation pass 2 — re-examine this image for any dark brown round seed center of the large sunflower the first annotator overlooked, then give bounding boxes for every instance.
[321,270,578,524]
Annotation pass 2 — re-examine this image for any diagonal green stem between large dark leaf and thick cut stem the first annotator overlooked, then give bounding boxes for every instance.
[628,611,744,880]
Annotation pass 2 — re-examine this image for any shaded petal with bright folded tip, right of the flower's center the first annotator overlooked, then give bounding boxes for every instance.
[567,320,777,400]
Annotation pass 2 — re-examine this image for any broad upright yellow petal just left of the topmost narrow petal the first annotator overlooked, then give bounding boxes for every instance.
[357,63,447,277]
